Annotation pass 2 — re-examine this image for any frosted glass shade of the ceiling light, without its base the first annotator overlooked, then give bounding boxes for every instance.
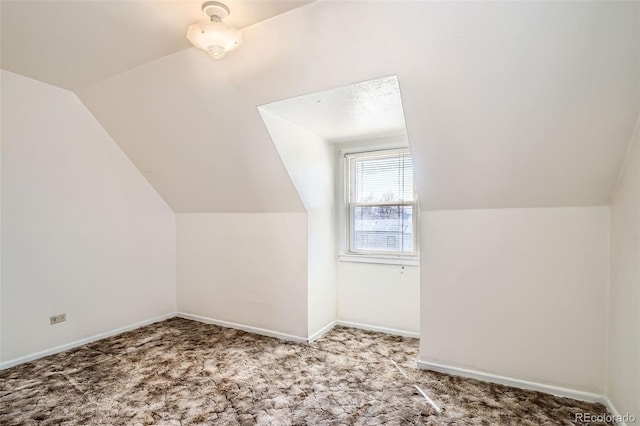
[187,21,242,59]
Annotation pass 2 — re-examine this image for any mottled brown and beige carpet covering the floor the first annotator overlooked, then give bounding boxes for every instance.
[0,318,605,425]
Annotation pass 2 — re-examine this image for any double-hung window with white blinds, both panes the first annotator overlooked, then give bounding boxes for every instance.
[345,149,418,256]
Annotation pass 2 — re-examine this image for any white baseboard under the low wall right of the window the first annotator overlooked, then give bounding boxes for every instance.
[418,361,604,404]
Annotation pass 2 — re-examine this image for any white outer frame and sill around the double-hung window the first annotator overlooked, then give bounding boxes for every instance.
[336,137,420,266]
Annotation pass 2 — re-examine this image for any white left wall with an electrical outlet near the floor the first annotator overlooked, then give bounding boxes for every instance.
[1,71,176,361]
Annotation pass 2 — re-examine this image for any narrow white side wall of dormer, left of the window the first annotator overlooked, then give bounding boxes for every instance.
[260,105,336,336]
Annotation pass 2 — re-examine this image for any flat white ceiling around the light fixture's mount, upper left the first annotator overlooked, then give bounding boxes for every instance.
[0,0,313,90]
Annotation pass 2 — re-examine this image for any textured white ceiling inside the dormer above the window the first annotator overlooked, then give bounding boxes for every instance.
[261,76,405,143]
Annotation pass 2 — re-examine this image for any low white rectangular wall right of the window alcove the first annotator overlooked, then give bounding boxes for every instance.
[420,207,609,394]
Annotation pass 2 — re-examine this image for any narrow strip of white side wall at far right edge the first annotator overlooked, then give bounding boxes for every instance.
[607,117,640,418]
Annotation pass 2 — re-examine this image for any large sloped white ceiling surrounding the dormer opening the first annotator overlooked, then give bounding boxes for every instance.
[2,1,640,212]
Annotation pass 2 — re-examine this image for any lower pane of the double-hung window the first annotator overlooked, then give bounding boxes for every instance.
[351,206,415,254]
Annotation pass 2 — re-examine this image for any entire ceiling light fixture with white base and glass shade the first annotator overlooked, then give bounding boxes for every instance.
[187,1,242,59]
